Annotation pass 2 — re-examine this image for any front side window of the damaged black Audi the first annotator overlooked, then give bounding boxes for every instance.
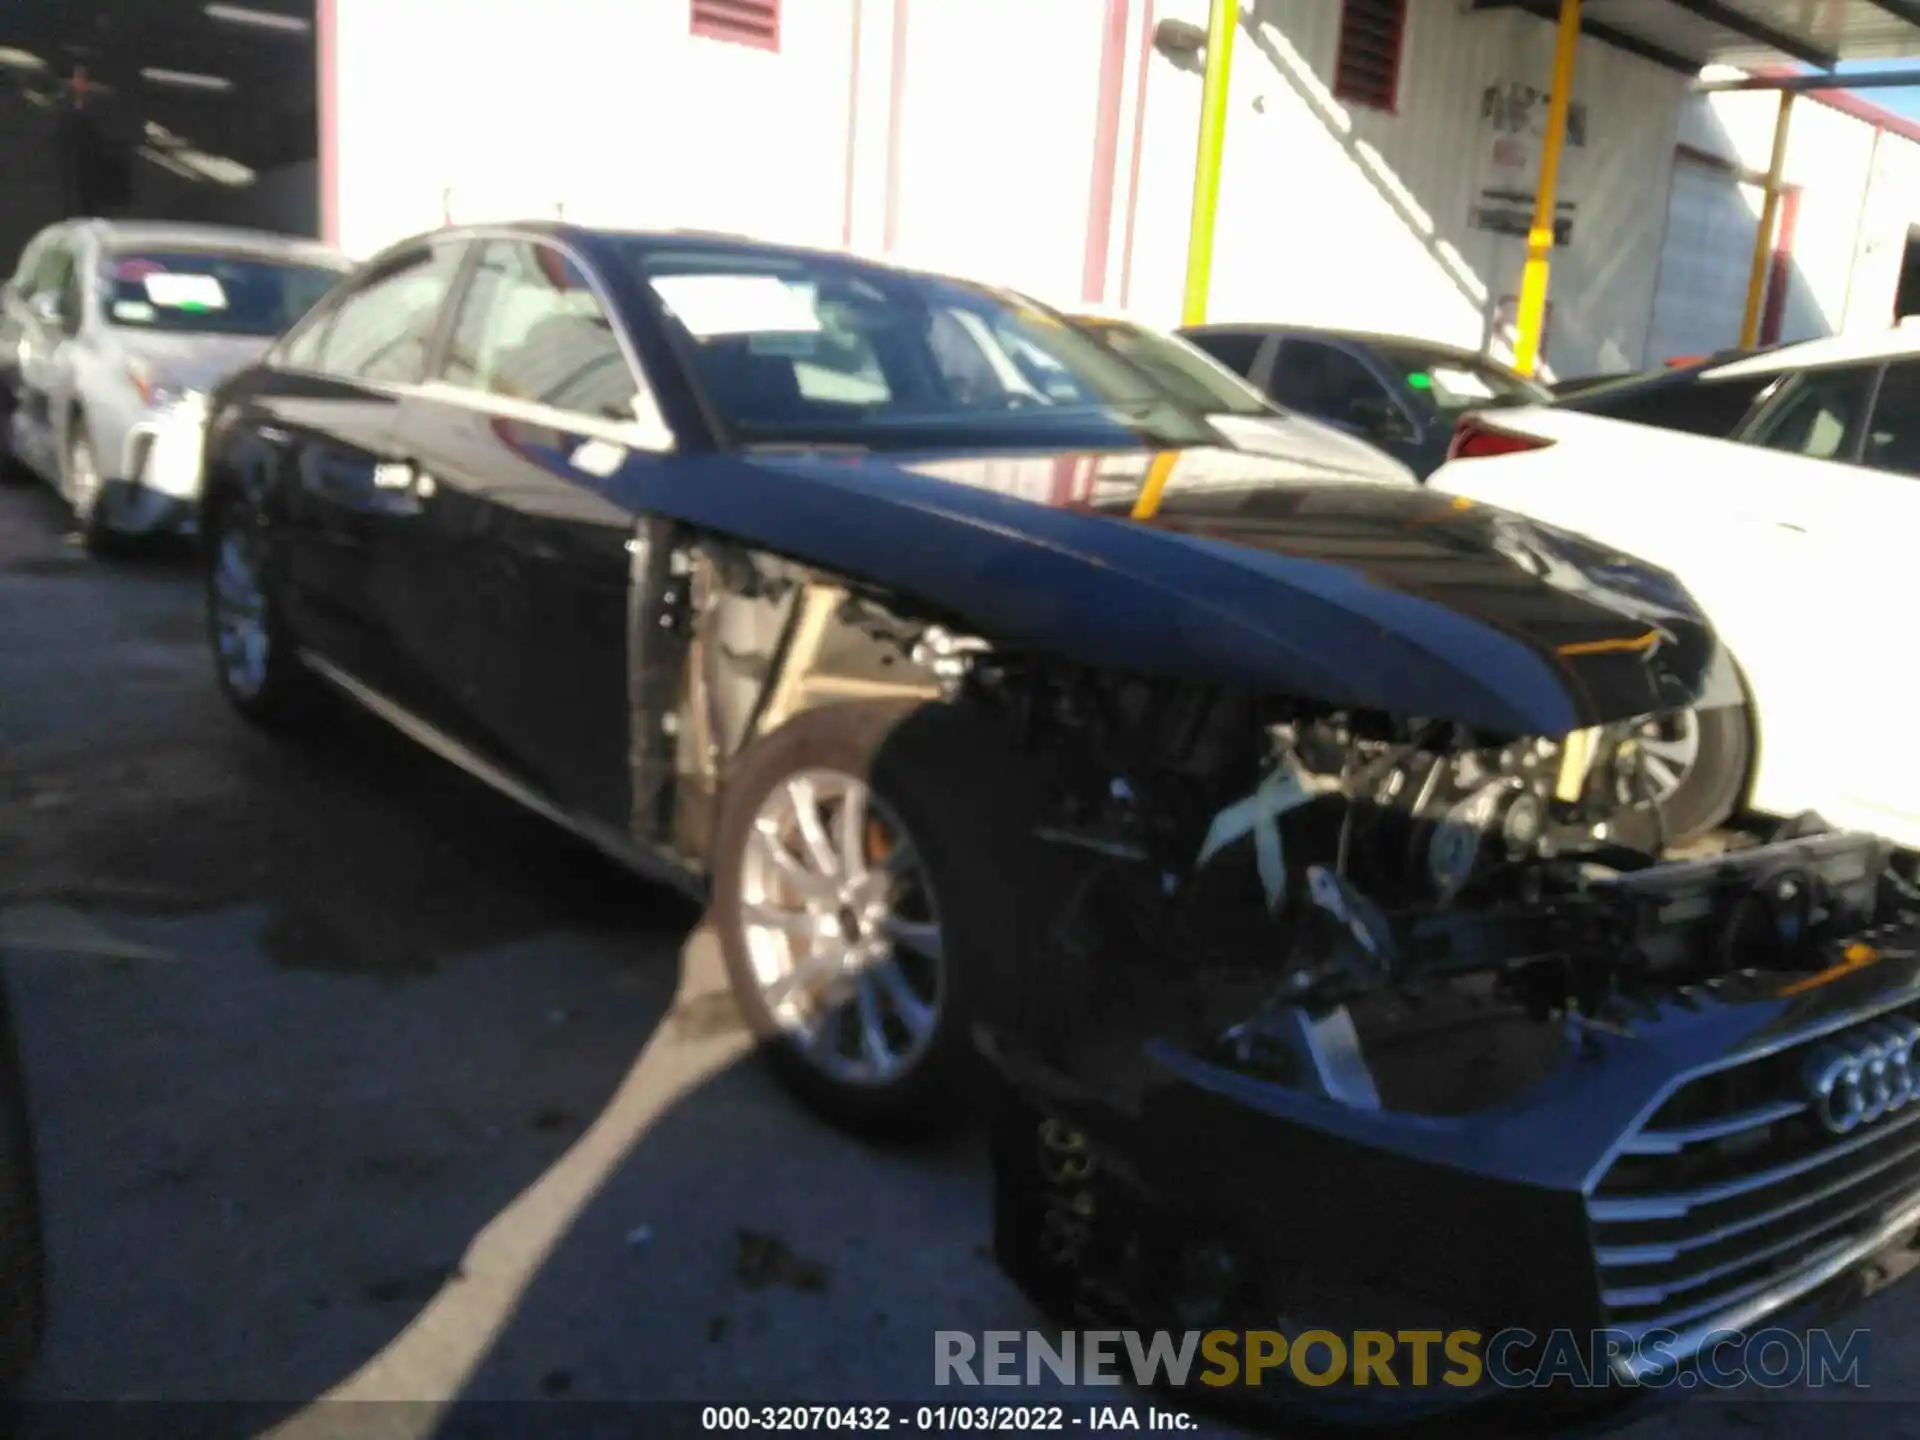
[440,240,651,420]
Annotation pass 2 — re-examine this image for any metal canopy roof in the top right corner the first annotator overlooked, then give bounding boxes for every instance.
[1473,0,1920,75]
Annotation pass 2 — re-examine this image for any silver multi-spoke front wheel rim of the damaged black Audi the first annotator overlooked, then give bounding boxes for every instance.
[739,768,947,1087]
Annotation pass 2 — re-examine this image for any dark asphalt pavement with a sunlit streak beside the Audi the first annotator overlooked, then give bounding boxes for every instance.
[0,488,1920,1436]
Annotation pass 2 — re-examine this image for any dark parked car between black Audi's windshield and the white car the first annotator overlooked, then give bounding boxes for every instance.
[1181,324,1553,480]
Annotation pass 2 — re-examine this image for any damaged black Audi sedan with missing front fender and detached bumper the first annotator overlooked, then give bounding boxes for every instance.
[202,225,1920,1420]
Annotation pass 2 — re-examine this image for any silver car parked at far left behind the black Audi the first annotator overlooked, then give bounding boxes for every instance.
[0,219,349,549]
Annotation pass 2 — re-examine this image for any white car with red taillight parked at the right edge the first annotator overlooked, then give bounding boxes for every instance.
[1430,324,1920,845]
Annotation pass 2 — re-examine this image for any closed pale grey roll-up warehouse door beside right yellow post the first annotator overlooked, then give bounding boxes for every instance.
[1645,156,1763,367]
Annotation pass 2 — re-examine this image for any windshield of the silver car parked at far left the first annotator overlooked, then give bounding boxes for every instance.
[100,250,342,336]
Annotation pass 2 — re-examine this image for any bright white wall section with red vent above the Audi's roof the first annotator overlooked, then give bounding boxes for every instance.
[334,0,860,253]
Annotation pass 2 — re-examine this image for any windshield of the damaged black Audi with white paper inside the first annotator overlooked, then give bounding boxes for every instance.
[636,248,1215,449]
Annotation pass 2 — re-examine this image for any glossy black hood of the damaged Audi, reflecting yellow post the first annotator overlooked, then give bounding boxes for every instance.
[645,449,1740,735]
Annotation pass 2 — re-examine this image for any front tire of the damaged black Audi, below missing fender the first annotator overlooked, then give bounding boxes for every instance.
[710,703,1044,1139]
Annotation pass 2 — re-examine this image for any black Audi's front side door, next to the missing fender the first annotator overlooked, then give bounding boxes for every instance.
[390,238,672,829]
